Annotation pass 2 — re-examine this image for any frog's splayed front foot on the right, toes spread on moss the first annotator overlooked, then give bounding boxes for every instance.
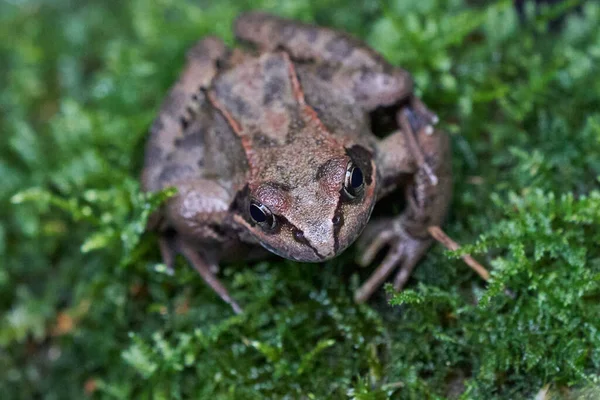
[354,217,432,303]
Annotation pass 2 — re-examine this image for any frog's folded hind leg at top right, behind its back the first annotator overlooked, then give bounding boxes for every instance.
[235,12,413,111]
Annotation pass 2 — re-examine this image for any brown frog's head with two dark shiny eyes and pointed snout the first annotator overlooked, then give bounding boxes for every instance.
[236,145,376,262]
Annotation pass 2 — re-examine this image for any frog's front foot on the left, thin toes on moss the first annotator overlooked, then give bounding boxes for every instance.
[159,235,242,314]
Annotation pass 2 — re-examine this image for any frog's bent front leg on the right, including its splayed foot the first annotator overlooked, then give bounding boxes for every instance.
[355,111,452,302]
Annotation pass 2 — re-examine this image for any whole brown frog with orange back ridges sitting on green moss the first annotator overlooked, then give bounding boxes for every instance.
[141,11,452,313]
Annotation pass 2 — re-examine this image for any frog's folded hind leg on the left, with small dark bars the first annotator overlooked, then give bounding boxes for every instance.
[142,37,228,191]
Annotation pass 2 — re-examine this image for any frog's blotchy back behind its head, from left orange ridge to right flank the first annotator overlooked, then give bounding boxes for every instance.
[212,51,368,148]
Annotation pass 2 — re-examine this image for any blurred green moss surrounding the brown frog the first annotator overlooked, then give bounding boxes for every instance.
[0,0,600,399]
